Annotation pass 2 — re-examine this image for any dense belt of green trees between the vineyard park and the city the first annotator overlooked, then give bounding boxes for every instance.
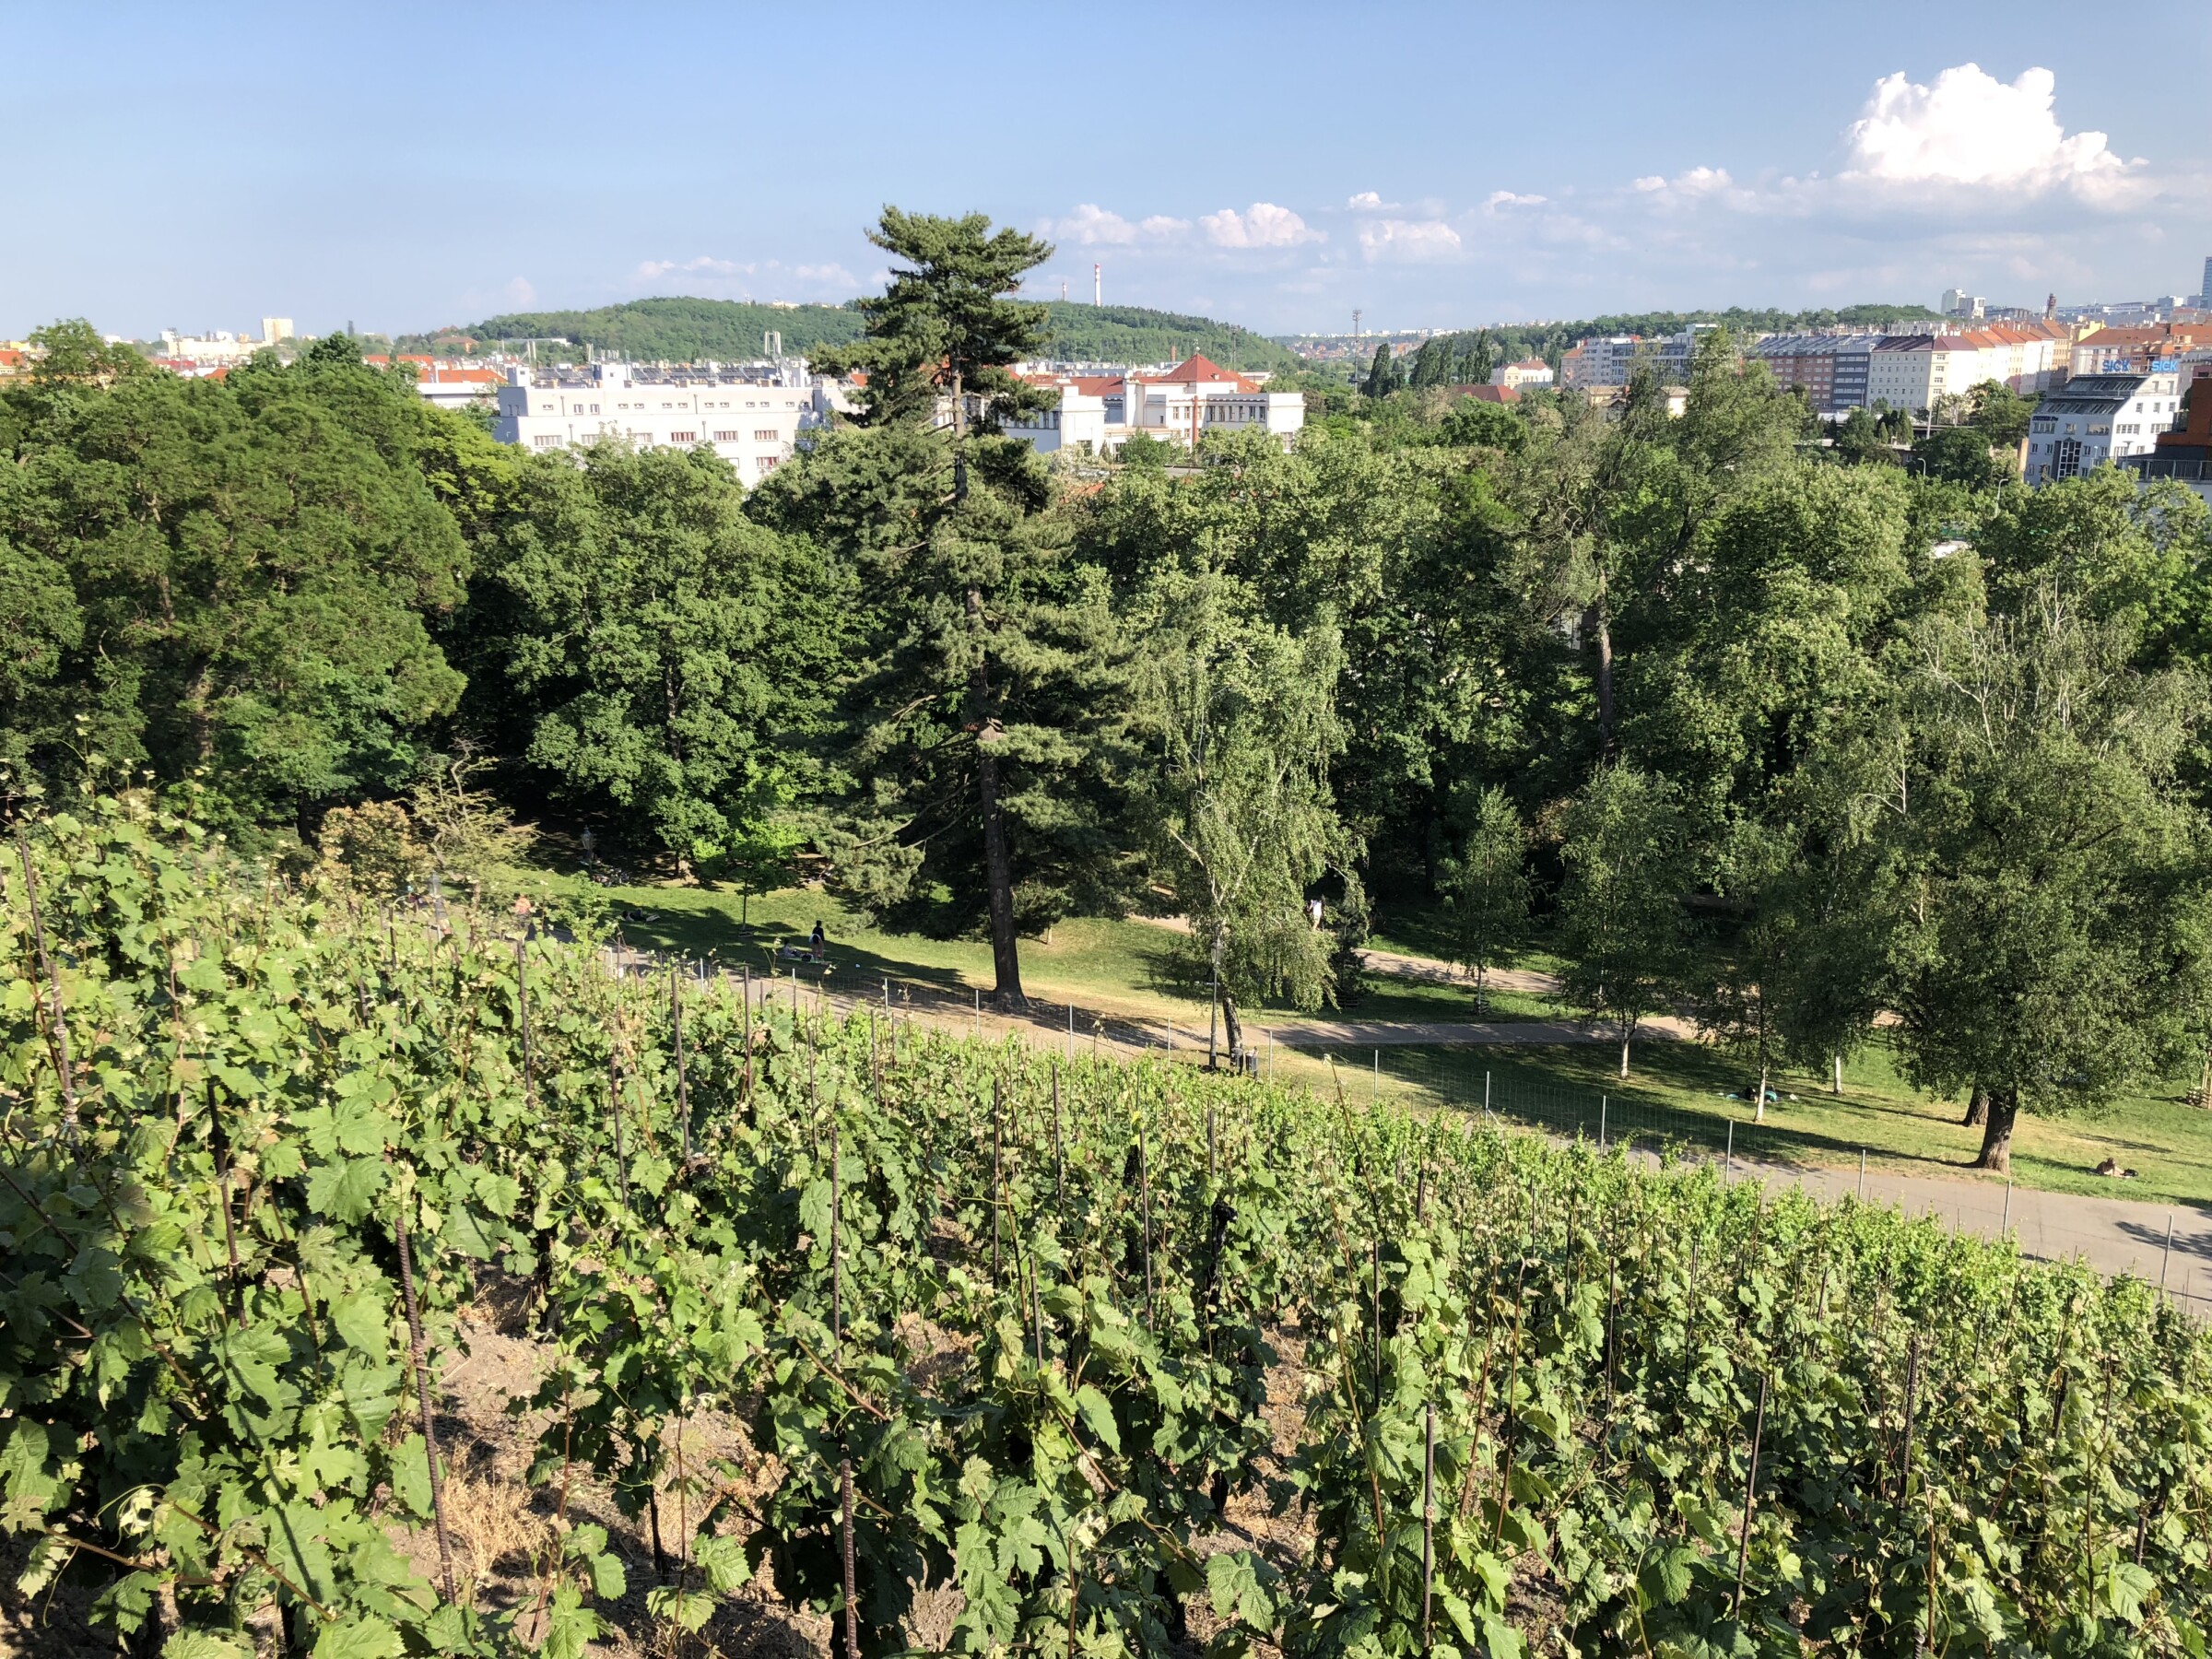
[0,210,2212,1168]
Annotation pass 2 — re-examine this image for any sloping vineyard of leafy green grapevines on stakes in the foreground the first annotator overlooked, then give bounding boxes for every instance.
[13,798,2212,1659]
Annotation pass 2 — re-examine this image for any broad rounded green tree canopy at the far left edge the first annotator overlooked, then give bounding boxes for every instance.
[0,338,469,825]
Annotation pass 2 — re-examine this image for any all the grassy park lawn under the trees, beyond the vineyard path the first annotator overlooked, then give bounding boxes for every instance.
[557,887,2212,1204]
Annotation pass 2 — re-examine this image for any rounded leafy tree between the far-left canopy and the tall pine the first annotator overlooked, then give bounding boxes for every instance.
[446,442,852,872]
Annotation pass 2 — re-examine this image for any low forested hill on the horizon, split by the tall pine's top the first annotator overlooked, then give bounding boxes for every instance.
[400,299,1296,370]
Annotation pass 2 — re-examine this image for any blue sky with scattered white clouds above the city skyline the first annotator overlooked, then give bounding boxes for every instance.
[0,0,2212,336]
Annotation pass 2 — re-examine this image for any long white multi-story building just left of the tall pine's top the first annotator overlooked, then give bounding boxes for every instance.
[491,363,830,485]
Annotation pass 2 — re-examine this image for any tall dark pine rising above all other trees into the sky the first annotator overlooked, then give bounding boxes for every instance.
[752,208,1119,1008]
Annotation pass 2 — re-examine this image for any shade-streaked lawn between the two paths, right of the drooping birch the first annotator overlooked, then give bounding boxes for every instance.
[1277,1040,2212,1206]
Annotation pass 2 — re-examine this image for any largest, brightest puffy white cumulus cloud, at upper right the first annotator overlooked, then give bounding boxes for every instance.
[1845,65,2144,197]
